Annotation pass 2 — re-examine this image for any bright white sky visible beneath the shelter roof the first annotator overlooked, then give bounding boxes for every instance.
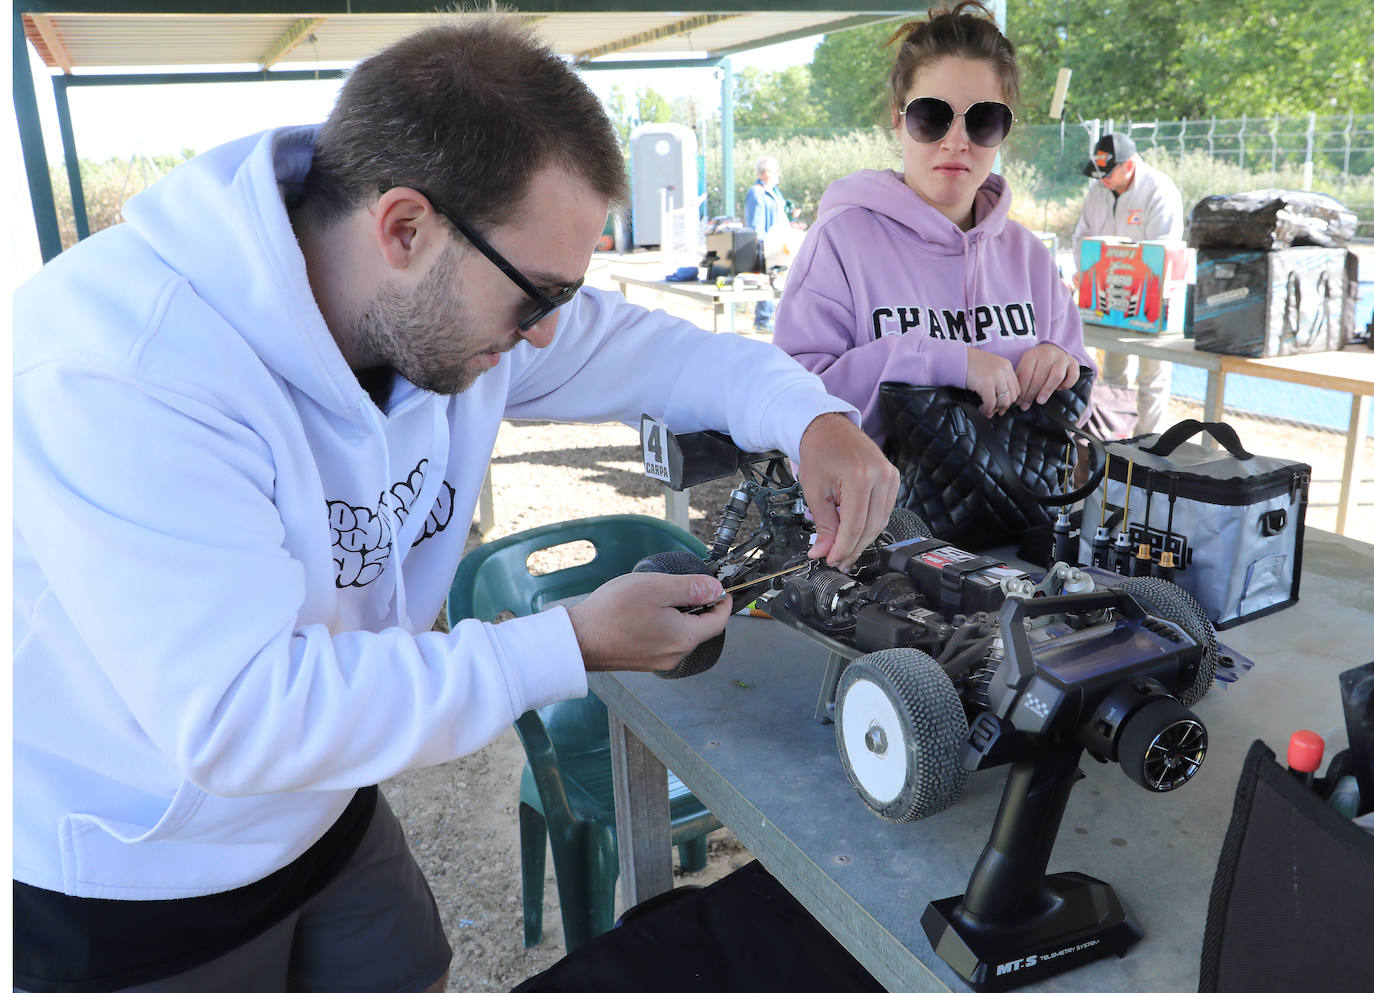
[21,34,820,163]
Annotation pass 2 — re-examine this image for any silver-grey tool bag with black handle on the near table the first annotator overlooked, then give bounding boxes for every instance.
[1079,419,1312,628]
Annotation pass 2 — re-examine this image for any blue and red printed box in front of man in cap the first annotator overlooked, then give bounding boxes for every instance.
[1079,238,1189,334]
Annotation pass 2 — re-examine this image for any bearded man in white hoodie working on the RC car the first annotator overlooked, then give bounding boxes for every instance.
[14,18,897,993]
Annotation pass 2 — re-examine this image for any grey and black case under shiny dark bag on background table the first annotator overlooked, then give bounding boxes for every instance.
[1193,247,1355,357]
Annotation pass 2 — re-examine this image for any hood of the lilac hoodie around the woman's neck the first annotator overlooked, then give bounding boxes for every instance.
[819,169,1011,255]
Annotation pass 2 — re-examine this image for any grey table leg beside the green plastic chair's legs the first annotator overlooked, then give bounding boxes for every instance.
[609,710,673,908]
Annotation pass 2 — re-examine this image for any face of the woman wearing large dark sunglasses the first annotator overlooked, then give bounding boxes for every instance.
[892,55,1006,231]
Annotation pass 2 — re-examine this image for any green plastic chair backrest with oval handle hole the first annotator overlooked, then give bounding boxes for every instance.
[448,514,708,626]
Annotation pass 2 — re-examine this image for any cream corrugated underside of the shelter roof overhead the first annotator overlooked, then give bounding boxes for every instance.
[16,7,910,71]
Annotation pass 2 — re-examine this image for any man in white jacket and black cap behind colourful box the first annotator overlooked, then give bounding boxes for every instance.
[1073,135,1183,434]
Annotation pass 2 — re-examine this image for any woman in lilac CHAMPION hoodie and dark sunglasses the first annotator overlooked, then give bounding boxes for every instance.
[774,0,1095,444]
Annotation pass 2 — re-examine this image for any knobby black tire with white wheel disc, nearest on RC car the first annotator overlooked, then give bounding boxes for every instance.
[835,648,969,821]
